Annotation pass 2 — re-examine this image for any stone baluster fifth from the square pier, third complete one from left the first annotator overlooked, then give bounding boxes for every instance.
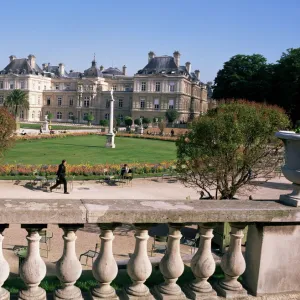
[91,224,118,300]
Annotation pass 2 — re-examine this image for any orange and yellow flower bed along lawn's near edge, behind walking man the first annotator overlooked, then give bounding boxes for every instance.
[0,161,176,176]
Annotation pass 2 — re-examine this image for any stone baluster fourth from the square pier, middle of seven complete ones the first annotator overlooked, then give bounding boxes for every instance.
[125,224,154,300]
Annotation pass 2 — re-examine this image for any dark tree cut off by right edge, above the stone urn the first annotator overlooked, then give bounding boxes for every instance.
[268,48,300,124]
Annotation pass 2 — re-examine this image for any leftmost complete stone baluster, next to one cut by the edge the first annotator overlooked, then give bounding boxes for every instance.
[19,224,47,300]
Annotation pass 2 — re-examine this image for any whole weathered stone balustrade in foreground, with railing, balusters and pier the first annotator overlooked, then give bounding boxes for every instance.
[0,199,300,300]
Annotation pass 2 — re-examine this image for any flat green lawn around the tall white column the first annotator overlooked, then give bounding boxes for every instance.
[2,135,176,164]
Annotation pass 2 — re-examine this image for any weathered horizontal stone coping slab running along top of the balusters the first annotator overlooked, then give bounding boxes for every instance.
[0,199,300,224]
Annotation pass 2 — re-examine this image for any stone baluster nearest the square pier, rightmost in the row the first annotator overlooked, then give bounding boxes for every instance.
[216,223,247,298]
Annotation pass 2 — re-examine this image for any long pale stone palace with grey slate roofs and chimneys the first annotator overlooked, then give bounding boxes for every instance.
[0,51,209,124]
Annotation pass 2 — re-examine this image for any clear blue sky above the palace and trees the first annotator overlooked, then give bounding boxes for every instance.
[0,0,300,82]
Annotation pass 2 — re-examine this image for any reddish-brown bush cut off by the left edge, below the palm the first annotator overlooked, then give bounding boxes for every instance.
[0,107,16,156]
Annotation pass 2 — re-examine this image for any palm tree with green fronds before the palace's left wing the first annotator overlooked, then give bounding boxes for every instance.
[4,89,29,119]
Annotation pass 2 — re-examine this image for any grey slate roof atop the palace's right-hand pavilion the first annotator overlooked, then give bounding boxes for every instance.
[137,55,189,75]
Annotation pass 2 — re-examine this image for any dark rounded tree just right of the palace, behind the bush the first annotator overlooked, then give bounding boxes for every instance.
[212,54,273,102]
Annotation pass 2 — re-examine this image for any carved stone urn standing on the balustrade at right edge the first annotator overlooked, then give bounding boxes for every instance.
[275,131,300,206]
